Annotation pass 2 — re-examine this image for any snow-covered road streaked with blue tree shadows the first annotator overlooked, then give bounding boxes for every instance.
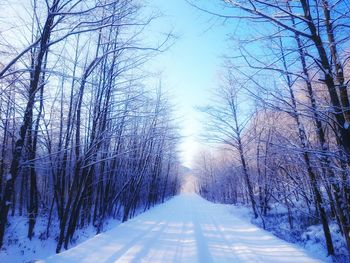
[43,194,322,263]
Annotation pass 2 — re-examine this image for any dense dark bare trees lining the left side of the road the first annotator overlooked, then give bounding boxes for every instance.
[0,0,179,253]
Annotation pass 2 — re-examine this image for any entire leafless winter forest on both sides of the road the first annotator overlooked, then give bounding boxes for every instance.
[0,0,350,262]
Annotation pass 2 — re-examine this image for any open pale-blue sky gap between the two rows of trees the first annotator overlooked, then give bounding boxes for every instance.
[146,0,232,167]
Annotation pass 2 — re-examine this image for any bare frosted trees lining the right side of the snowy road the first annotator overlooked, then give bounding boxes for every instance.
[194,0,350,260]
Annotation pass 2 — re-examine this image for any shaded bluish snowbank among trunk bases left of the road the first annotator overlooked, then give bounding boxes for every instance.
[0,216,120,263]
